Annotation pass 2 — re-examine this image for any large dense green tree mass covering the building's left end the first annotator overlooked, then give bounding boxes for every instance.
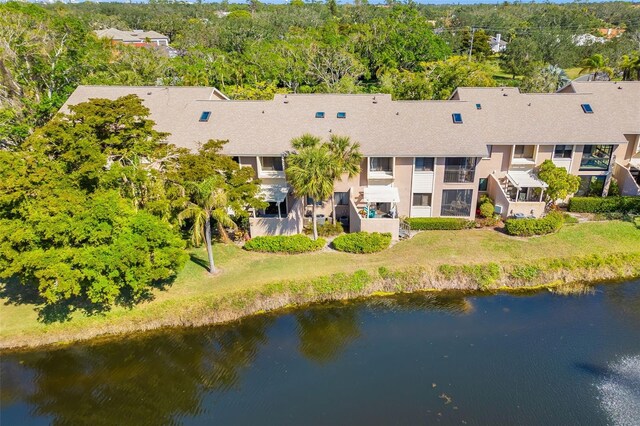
[0,96,185,306]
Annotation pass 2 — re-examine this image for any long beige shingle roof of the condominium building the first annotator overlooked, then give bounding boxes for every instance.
[63,83,640,156]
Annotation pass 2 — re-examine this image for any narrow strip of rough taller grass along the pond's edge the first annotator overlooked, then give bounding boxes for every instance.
[0,252,640,352]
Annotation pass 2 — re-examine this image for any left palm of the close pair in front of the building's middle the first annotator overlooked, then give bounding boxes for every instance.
[285,140,333,239]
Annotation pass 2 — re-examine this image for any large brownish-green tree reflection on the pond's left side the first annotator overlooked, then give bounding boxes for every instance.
[1,317,272,425]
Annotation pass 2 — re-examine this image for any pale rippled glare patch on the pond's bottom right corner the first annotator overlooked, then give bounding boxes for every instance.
[596,355,640,426]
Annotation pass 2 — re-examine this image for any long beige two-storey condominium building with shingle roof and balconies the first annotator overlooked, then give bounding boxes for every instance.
[63,82,640,238]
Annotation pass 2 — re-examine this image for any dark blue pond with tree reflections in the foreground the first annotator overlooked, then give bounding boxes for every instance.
[0,281,640,426]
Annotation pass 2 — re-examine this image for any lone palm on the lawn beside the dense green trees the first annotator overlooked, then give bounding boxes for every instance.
[178,176,236,274]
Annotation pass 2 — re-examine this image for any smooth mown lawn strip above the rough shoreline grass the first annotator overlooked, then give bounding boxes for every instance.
[0,221,640,339]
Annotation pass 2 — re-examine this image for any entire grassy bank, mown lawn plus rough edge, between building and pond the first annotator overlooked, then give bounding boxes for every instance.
[0,221,640,349]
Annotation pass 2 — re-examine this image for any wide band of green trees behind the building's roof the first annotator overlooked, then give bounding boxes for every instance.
[0,0,640,147]
